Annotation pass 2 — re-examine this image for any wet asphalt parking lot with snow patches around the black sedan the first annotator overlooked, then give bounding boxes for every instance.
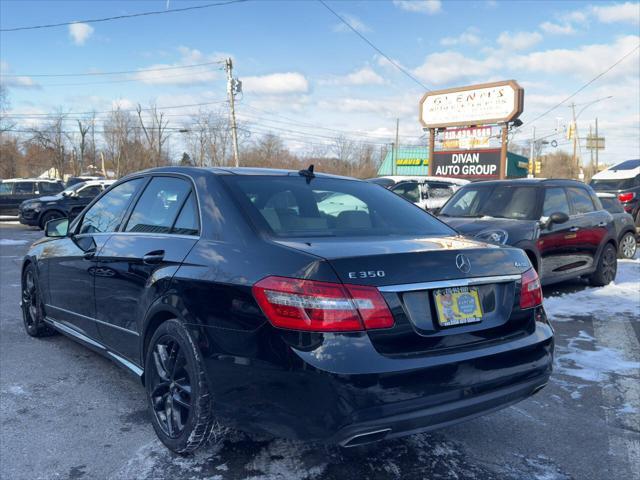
[0,221,640,480]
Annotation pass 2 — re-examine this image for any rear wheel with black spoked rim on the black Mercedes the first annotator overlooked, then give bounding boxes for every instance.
[145,319,215,454]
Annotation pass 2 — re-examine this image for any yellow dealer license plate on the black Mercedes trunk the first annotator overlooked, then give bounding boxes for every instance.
[433,287,482,327]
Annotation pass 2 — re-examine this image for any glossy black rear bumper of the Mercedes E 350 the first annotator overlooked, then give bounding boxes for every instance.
[200,314,553,445]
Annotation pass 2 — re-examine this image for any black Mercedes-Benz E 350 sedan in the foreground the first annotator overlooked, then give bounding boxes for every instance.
[22,167,553,452]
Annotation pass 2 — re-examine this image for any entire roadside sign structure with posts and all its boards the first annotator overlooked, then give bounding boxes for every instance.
[419,80,524,178]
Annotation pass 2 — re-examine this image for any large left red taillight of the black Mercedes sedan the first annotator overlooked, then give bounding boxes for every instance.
[253,277,393,332]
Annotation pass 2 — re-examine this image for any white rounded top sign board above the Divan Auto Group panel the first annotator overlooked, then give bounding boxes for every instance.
[420,80,524,128]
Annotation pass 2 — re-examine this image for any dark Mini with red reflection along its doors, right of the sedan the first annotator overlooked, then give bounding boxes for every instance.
[439,179,618,285]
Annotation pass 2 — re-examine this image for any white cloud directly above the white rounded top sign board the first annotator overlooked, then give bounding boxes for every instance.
[413,51,501,85]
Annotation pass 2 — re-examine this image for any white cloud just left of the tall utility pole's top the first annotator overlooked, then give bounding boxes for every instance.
[133,46,222,85]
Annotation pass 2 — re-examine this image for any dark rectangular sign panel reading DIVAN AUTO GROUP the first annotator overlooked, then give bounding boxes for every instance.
[431,149,500,179]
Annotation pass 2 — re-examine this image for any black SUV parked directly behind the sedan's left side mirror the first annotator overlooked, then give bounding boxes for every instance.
[18,180,114,228]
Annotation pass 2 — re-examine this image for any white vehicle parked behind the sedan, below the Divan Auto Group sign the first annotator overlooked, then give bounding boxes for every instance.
[387,177,469,210]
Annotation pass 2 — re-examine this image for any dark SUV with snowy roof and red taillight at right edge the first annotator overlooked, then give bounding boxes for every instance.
[589,159,640,232]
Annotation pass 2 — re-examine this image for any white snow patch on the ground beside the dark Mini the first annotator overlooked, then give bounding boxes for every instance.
[544,256,640,321]
